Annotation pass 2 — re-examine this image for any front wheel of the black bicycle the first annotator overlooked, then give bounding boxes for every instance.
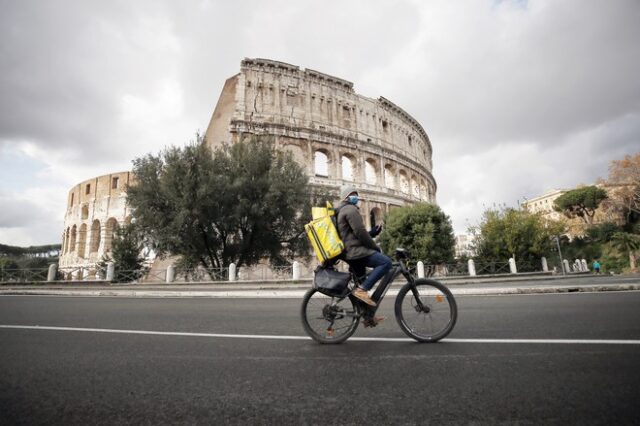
[395,278,458,342]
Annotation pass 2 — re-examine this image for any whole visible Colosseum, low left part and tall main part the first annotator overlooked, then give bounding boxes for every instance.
[60,59,437,277]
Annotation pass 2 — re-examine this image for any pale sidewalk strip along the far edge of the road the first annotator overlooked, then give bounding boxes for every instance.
[0,274,640,298]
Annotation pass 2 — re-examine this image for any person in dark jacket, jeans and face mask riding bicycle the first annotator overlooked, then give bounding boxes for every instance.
[338,186,391,314]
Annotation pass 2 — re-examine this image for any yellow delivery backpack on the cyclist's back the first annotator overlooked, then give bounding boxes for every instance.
[304,201,344,263]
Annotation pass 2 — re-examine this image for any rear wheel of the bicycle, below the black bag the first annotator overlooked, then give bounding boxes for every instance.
[300,288,360,343]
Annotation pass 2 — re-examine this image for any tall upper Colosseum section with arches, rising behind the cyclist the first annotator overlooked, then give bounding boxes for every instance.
[205,59,437,225]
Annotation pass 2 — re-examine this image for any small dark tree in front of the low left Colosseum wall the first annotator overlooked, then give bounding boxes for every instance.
[98,224,146,282]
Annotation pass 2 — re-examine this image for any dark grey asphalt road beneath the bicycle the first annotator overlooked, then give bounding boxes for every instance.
[0,292,640,425]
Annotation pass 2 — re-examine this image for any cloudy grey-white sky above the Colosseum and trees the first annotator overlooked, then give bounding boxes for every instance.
[0,0,640,246]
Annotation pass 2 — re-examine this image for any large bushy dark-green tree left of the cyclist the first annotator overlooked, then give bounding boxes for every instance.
[128,137,310,269]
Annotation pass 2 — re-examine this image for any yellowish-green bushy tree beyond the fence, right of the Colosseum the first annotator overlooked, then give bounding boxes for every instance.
[473,208,564,262]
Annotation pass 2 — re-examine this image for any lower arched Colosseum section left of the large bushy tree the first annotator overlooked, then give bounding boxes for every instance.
[59,172,132,279]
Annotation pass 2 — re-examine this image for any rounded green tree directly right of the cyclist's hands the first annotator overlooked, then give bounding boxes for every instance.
[380,203,455,264]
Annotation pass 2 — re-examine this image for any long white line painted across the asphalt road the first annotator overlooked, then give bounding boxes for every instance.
[0,324,640,345]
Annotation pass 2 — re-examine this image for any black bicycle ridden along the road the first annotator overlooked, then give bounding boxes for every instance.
[300,248,458,344]
